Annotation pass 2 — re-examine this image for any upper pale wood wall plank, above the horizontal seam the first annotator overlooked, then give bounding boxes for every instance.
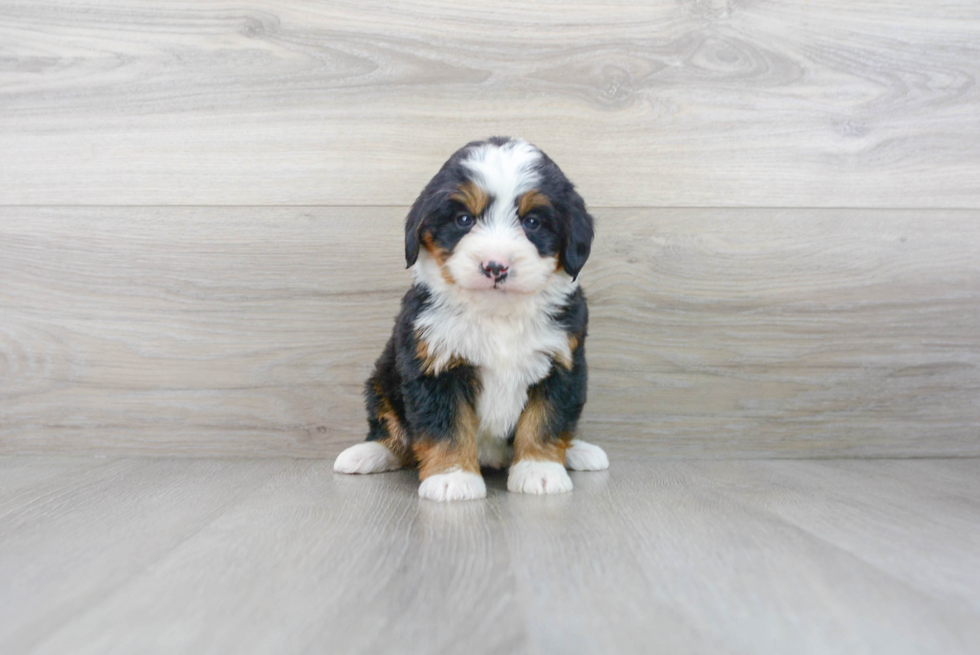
[0,0,980,208]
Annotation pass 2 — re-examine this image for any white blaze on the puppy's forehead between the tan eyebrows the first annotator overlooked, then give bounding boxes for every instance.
[463,140,541,224]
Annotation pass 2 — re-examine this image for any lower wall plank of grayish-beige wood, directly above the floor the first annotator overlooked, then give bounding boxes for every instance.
[0,207,980,457]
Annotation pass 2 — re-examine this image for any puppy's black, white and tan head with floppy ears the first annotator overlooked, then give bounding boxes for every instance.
[405,137,593,294]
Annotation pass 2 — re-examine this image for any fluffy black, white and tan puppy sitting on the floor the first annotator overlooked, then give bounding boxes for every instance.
[334,137,609,500]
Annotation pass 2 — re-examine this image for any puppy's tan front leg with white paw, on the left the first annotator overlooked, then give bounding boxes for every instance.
[412,398,487,500]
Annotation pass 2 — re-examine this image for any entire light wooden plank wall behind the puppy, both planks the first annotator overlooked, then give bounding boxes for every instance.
[0,0,980,457]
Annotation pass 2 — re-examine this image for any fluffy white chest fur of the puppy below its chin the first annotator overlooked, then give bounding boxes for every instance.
[415,278,575,441]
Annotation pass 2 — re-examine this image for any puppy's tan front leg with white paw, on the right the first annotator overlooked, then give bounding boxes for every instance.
[507,387,572,494]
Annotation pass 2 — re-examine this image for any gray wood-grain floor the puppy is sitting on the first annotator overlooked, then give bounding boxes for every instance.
[0,449,980,655]
